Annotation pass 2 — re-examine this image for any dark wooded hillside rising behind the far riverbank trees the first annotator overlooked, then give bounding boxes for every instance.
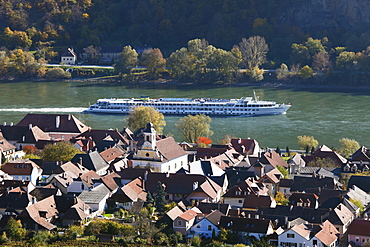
[0,0,370,61]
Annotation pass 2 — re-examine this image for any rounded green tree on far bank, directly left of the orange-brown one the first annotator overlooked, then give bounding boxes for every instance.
[114,46,139,74]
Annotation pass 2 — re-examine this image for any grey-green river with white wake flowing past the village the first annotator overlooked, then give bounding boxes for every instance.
[0,81,370,149]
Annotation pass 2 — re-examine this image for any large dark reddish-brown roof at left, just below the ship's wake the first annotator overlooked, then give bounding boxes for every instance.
[17,113,88,133]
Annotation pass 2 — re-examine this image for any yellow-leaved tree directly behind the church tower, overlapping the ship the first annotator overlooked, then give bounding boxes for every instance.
[125,106,166,134]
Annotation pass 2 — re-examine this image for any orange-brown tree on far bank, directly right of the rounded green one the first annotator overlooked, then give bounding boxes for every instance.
[141,48,166,76]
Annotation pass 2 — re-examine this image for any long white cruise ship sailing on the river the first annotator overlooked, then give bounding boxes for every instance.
[84,94,291,116]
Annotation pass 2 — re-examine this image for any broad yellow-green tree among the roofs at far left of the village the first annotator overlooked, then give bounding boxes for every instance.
[41,141,83,161]
